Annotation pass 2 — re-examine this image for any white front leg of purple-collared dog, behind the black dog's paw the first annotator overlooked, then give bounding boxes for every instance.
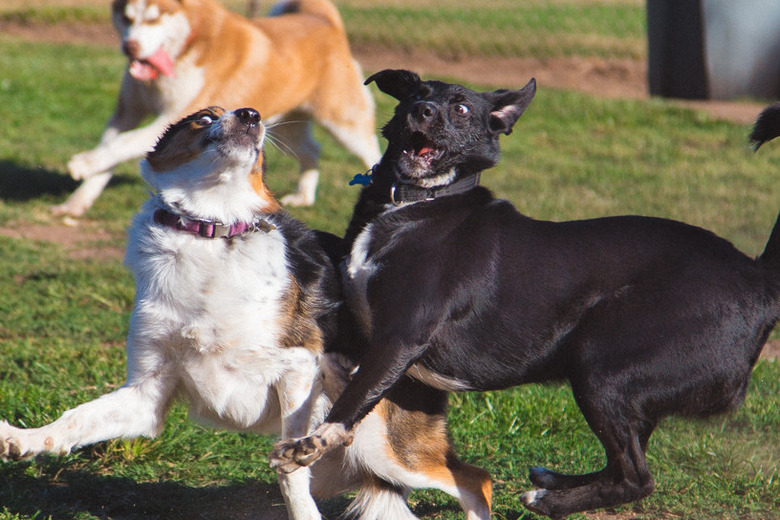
[277,359,324,520]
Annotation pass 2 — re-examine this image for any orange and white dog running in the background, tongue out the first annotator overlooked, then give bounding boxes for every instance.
[53,0,380,216]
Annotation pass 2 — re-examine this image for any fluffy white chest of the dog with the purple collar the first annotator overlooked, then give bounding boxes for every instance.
[126,219,316,431]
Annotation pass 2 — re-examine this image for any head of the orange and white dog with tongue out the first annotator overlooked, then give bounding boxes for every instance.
[112,0,192,81]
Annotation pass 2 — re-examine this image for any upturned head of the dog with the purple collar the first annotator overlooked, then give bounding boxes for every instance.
[141,107,279,223]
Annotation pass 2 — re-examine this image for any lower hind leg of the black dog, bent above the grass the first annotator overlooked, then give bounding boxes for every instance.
[523,400,654,518]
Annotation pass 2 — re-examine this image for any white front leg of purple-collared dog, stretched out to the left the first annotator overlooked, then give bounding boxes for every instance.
[0,381,171,459]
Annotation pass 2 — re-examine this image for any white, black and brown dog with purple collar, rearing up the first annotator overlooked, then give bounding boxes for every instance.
[0,107,491,520]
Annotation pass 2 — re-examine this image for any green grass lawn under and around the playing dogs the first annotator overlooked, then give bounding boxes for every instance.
[0,0,780,520]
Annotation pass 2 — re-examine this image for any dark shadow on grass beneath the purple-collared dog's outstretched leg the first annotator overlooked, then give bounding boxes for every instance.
[0,463,287,520]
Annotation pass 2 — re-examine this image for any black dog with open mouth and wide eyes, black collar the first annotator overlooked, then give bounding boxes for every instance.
[275,70,780,518]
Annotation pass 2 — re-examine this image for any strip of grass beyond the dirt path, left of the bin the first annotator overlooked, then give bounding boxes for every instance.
[341,2,645,59]
